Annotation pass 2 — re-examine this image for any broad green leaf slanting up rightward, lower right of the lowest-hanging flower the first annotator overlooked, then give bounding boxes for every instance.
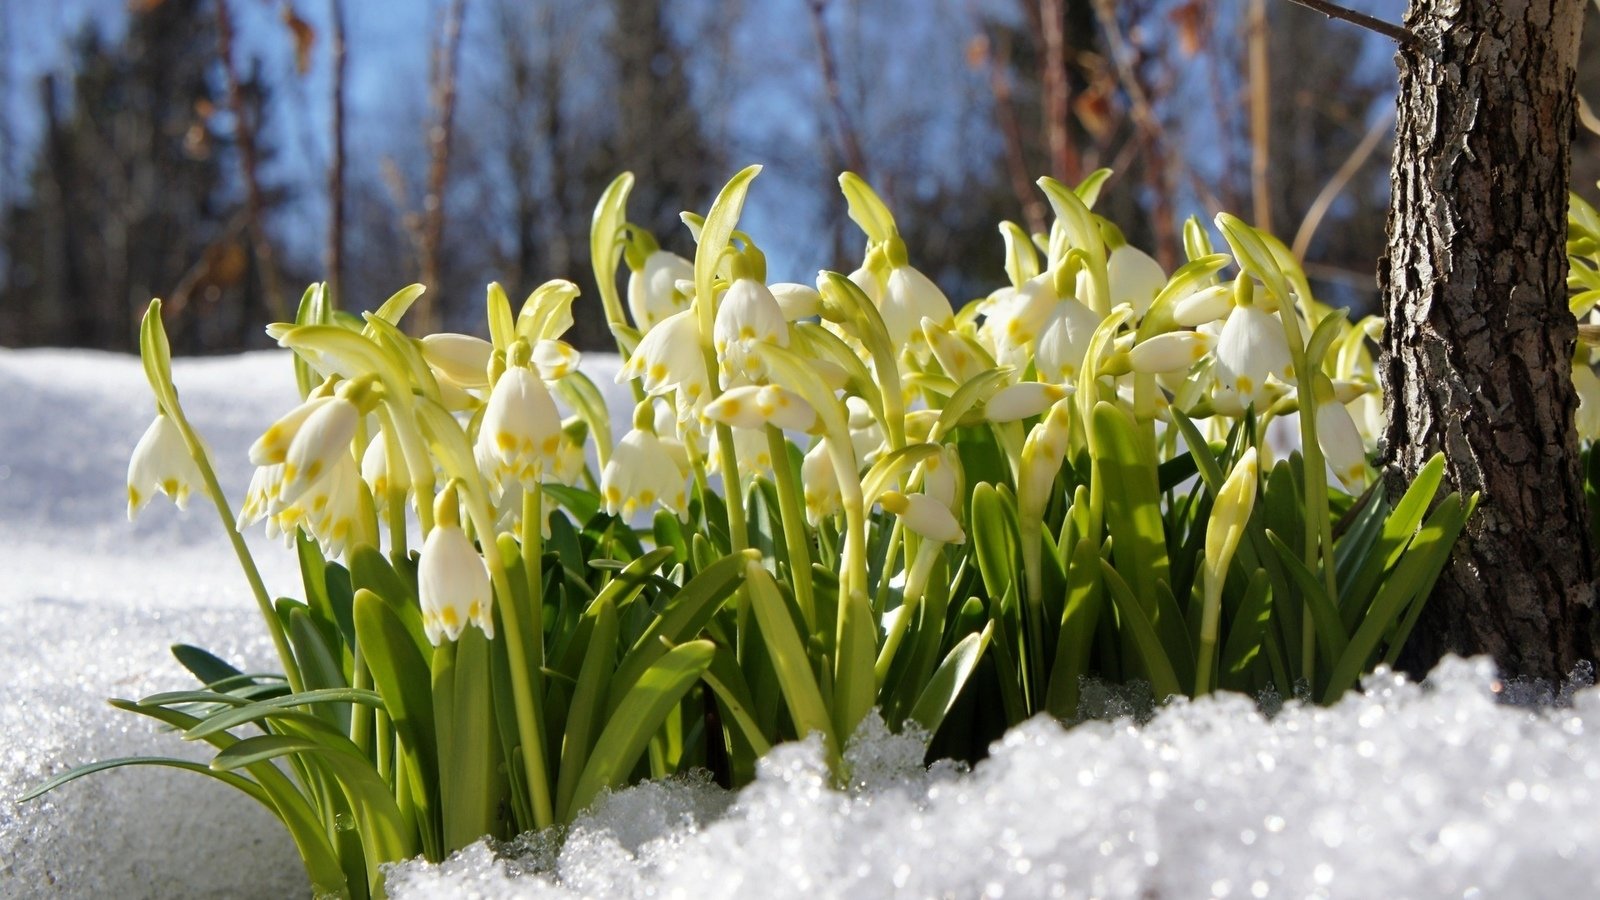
[570,641,715,814]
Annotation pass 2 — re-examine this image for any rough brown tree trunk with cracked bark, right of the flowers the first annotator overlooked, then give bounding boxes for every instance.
[1379,0,1595,677]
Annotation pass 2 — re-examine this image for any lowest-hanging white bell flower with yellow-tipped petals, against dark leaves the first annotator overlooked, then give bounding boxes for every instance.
[416,482,494,647]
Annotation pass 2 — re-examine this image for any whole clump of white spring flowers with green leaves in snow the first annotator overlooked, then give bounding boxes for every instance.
[31,167,1472,897]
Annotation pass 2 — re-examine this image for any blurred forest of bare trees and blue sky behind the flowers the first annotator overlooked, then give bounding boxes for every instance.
[0,0,1600,352]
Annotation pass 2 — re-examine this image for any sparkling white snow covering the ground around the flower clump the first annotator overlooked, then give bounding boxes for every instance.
[0,344,1600,898]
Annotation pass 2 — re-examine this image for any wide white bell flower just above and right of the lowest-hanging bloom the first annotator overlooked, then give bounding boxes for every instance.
[475,340,562,488]
